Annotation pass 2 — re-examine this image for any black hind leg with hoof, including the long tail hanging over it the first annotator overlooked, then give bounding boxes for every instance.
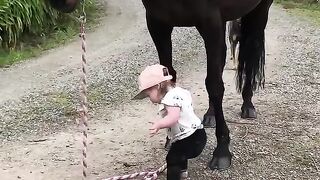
[237,0,273,118]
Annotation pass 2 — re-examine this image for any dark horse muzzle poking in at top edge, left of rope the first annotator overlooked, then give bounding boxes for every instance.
[49,0,80,13]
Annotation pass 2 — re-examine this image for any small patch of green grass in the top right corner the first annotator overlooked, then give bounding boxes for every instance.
[275,0,320,25]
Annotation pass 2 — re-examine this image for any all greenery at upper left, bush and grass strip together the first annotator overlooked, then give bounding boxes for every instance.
[0,0,105,68]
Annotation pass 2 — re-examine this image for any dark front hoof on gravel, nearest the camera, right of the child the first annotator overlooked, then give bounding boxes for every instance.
[208,148,232,170]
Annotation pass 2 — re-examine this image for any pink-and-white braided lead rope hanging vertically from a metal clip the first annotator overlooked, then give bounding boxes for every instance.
[79,0,88,180]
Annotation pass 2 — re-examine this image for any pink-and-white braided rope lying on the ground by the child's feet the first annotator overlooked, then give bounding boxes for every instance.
[103,164,167,180]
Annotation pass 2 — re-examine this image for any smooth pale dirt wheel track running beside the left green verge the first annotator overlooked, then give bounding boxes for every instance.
[0,1,140,103]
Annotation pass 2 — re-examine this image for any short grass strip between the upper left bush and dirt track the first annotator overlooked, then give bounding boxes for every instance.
[0,1,104,68]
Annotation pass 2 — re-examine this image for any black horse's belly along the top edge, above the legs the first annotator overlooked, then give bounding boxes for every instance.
[142,0,264,22]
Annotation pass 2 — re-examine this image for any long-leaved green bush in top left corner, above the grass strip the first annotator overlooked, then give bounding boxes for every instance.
[0,0,92,50]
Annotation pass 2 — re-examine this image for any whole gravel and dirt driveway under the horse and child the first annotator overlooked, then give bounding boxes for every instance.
[0,0,320,180]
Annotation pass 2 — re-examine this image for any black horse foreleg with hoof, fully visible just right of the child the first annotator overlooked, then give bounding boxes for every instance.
[197,14,231,169]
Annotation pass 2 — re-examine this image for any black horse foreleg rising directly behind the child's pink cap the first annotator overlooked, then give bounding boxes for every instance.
[147,15,176,82]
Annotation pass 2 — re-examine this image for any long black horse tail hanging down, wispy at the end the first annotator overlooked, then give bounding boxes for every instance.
[237,8,265,92]
